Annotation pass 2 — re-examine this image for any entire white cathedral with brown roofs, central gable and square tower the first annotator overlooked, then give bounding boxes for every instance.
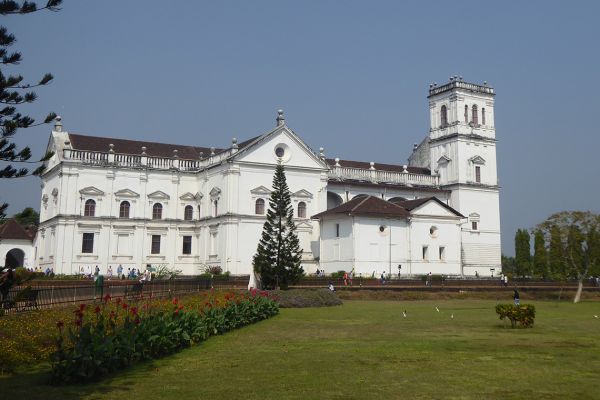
[31,77,501,276]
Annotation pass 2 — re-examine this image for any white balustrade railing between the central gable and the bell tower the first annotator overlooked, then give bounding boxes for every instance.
[329,166,438,186]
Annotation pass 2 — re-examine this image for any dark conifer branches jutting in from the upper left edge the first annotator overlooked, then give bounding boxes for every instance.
[0,0,62,220]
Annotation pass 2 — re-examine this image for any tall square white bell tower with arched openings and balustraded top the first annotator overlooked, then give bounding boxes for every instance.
[428,76,501,276]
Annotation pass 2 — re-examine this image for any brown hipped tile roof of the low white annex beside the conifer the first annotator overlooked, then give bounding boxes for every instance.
[312,196,409,219]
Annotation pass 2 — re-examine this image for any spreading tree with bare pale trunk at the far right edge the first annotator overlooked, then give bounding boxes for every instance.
[537,211,600,303]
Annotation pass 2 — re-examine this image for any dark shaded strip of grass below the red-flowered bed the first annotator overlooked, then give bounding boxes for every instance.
[0,357,168,400]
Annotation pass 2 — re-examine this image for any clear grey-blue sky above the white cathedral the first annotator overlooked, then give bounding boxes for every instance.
[0,0,600,254]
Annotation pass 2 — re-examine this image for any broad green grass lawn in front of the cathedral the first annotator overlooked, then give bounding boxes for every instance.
[0,300,600,400]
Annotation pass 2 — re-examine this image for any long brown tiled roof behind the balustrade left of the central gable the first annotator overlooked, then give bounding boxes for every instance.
[69,133,256,160]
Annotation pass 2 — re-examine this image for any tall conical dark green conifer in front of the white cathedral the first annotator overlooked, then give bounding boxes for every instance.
[253,163,304,289]
